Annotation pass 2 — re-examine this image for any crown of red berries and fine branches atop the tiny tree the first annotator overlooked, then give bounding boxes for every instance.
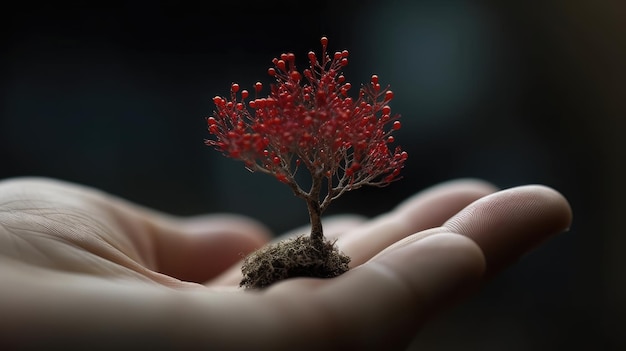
[206,37,407,201]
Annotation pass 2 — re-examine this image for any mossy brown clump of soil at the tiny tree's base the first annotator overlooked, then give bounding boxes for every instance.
[239,235,350,289]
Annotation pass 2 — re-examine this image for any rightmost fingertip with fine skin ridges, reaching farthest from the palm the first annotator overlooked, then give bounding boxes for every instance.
[444,185,572,274]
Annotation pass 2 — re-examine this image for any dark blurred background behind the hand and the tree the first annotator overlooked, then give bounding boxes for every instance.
[0,0,626,350]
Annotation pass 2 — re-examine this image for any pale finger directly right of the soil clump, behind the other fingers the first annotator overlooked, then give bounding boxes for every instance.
[337,179,496,267]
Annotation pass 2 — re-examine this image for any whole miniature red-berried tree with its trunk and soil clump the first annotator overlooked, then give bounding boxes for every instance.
[206,37,407,288]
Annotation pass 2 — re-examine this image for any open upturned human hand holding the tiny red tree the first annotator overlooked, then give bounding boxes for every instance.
[0,178,571,350]
